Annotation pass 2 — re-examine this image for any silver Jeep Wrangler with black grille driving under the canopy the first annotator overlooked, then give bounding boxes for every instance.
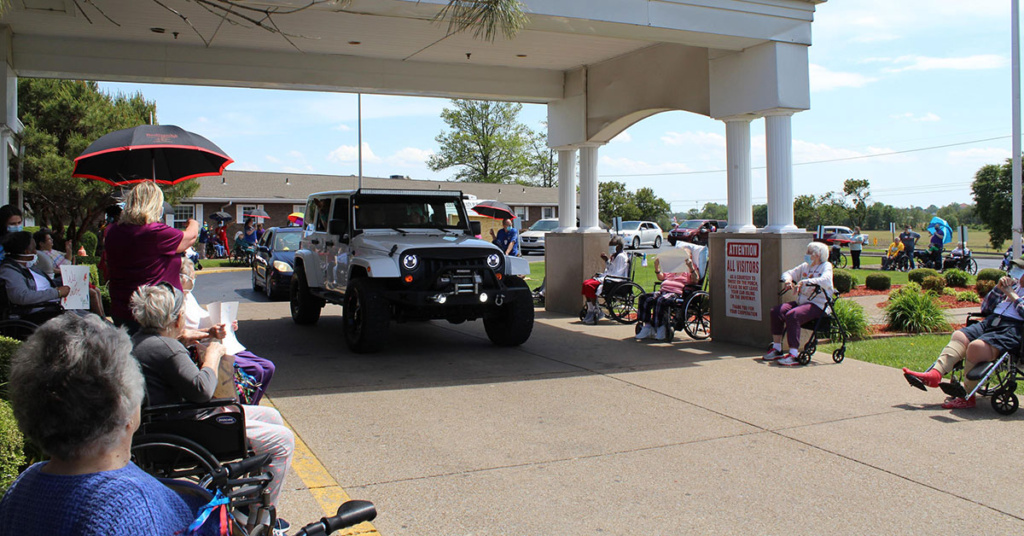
[290,189,534,353]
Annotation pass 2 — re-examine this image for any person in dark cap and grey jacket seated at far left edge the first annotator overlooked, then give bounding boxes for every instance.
[0,231,71,324]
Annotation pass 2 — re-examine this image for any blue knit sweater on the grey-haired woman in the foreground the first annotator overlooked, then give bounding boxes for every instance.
[0,462,194,536]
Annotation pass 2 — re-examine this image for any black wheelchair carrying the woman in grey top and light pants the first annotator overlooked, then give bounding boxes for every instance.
[131,399,278,536]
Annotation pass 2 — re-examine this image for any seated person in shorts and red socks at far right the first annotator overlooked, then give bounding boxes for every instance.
[903,259,1024,409]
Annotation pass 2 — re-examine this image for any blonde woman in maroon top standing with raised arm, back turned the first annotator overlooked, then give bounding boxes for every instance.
[103,181,199,333]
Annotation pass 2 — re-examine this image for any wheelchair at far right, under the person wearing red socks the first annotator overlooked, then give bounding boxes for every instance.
[939,313,1024,415]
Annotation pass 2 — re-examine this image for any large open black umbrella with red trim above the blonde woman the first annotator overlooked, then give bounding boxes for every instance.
[72,125,233,187]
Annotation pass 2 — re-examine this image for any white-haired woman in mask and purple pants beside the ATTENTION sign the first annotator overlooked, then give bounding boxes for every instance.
[762,242,835,367]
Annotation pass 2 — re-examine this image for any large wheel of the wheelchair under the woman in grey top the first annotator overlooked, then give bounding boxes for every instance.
[131,434,220,486]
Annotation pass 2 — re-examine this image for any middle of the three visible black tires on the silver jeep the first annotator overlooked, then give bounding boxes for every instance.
[342,278,391,354]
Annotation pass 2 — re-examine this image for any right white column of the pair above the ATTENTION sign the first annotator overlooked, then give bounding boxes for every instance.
[764,111,800,233]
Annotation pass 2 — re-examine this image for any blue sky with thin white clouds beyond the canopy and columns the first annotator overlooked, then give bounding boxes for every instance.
[100,0,1011,211]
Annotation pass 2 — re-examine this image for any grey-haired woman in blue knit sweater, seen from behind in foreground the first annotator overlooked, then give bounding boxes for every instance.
[0,315,195,536]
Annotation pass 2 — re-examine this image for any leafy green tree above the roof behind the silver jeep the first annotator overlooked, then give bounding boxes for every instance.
[427,99,535,182]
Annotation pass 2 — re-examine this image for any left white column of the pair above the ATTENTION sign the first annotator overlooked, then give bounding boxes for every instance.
[723,118,757,233]
